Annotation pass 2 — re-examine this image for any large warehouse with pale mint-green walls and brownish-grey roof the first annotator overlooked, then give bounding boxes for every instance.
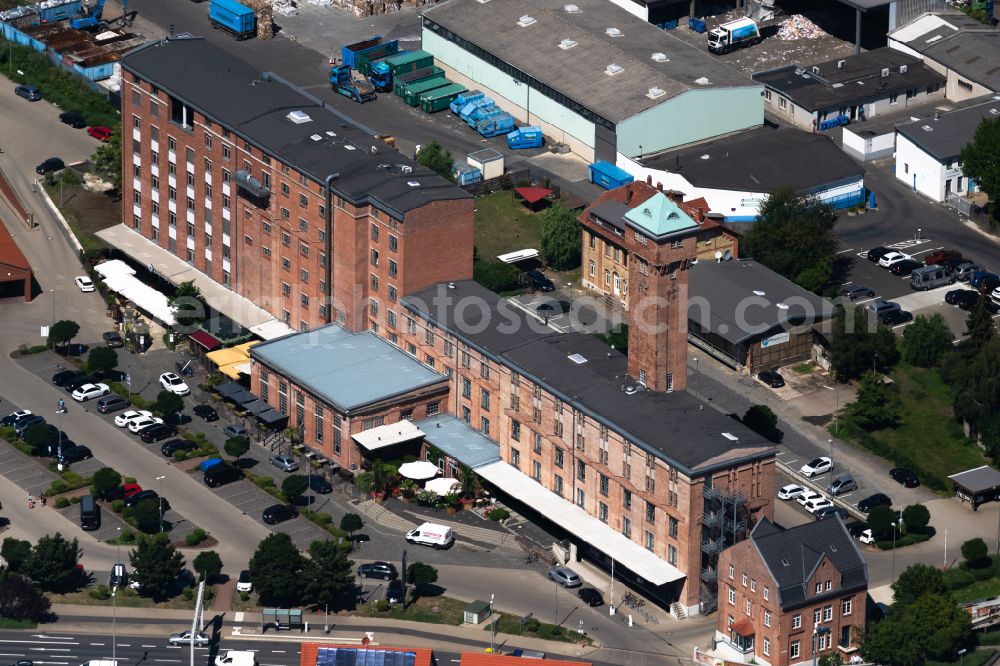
[422,0,764,163]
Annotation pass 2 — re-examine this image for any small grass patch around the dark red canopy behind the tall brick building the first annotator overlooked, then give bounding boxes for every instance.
[474,190,541,261]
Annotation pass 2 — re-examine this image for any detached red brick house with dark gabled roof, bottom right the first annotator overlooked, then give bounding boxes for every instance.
[715,517,868,666]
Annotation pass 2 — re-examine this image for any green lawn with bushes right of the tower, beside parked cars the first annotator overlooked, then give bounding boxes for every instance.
[836,364,988,491]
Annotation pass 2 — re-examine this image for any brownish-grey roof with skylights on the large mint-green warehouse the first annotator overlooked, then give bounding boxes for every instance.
[423,0,758,122]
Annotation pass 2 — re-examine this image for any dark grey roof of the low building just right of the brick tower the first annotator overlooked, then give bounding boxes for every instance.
[688,259,833,344]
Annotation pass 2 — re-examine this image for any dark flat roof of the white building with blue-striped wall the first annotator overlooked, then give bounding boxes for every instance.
[642,127,864,192]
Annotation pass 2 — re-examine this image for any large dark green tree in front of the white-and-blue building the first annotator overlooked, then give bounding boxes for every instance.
[740,188,837,291]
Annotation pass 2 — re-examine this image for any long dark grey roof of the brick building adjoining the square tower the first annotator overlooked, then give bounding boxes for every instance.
[403,281,774,473]
